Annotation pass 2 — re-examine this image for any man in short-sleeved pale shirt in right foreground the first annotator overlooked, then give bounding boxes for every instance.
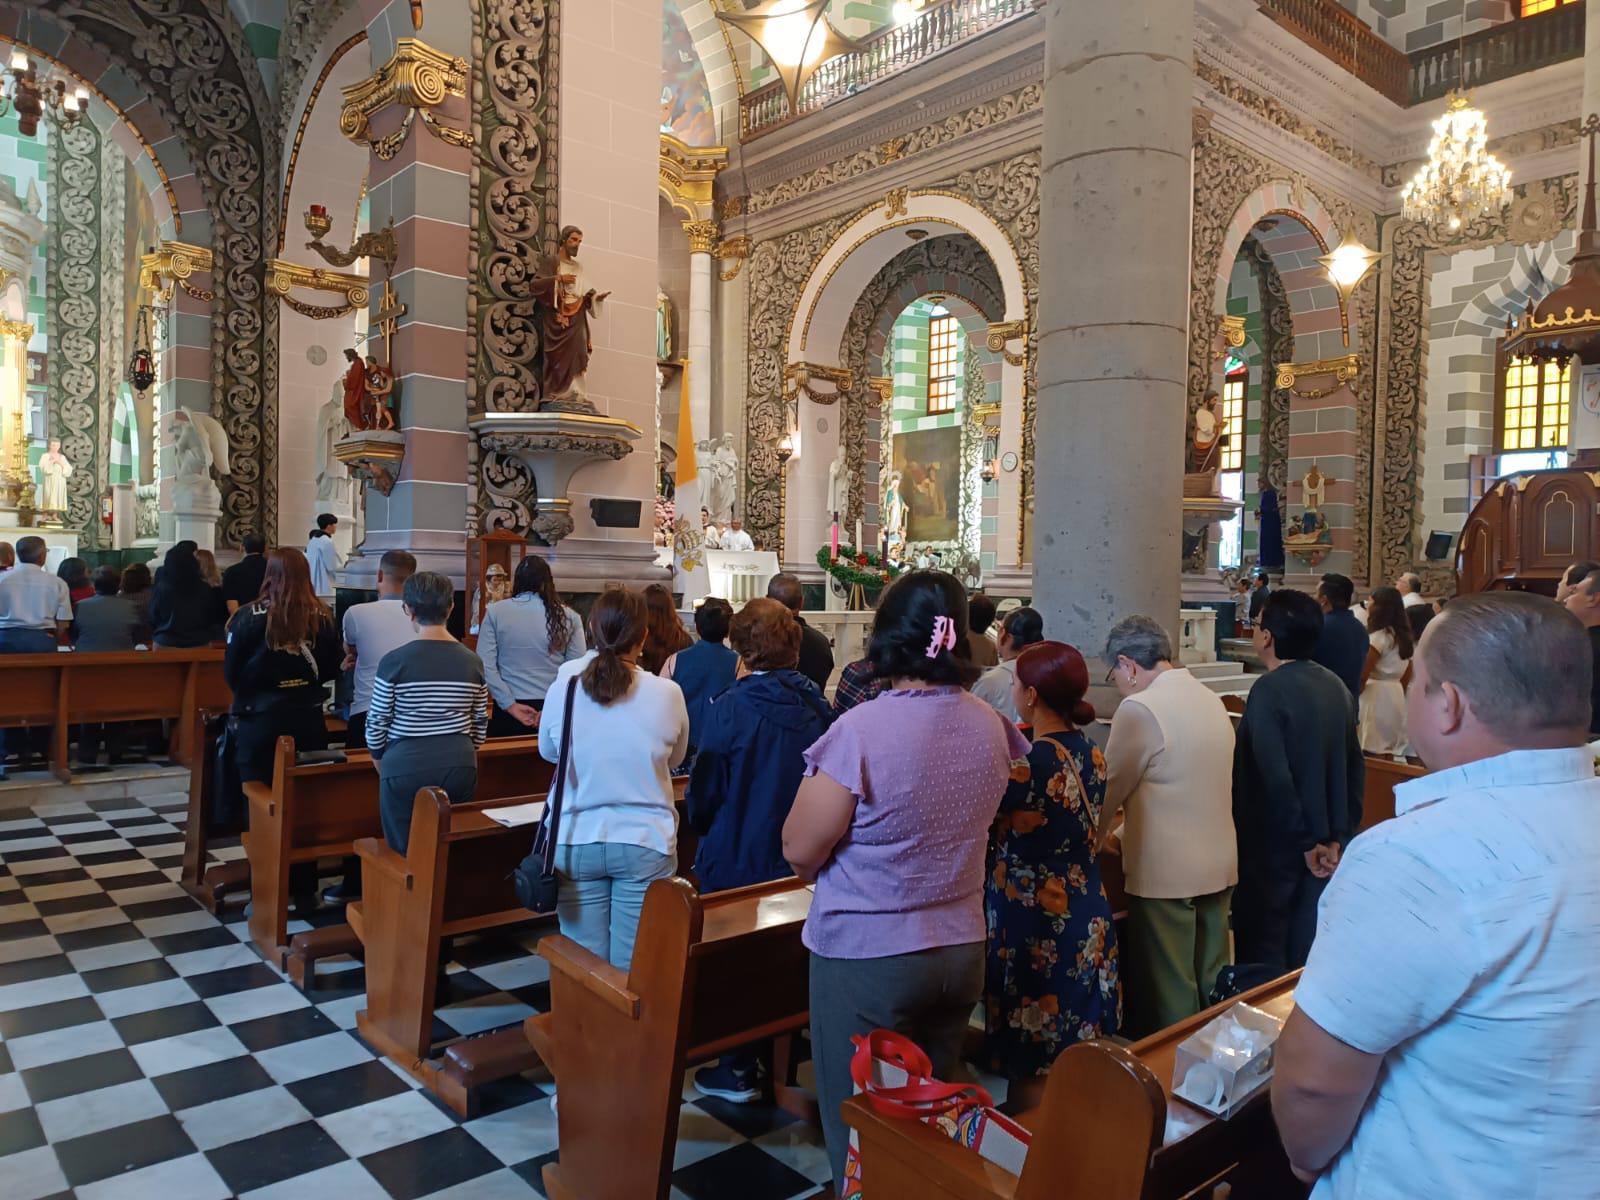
[1272,592,1600,1200]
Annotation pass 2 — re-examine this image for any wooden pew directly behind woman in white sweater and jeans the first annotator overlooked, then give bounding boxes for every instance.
[526,878,811,1200]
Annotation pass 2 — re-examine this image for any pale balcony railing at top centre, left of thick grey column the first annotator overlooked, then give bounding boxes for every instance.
[739,0,1035,139]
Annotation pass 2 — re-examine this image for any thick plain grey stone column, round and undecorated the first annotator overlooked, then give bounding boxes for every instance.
[1034,0,1194,656]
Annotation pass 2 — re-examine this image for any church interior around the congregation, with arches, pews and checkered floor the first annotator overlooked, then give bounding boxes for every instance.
[0,0,1600,1200]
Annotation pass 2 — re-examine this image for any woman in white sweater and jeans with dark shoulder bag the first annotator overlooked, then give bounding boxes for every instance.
[539,587,690,971]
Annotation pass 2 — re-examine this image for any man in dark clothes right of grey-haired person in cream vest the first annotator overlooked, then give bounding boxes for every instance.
[1234,590,1366,971]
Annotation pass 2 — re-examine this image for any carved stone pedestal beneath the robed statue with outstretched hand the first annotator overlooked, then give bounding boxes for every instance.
[472,411,643,547]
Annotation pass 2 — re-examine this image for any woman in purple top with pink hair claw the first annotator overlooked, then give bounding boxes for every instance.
[782,571,1027,1187]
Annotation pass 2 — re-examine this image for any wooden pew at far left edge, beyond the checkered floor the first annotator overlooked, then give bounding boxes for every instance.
[0,646,232,782]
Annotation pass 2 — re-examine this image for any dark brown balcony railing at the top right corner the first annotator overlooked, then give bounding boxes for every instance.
[1258,0,1587,107]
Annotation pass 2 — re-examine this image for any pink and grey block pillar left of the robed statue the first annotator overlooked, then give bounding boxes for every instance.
[344,0,472,590]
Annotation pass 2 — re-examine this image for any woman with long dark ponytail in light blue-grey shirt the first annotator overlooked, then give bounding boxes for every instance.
[477,554,586,738]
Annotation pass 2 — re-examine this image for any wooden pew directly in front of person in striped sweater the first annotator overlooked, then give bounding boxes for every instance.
[245,738,552,987]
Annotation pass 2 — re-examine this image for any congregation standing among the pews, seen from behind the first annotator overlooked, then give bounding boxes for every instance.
[0,522,1600,1197]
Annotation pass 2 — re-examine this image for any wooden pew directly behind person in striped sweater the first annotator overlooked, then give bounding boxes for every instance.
[349,790,554,1117]
